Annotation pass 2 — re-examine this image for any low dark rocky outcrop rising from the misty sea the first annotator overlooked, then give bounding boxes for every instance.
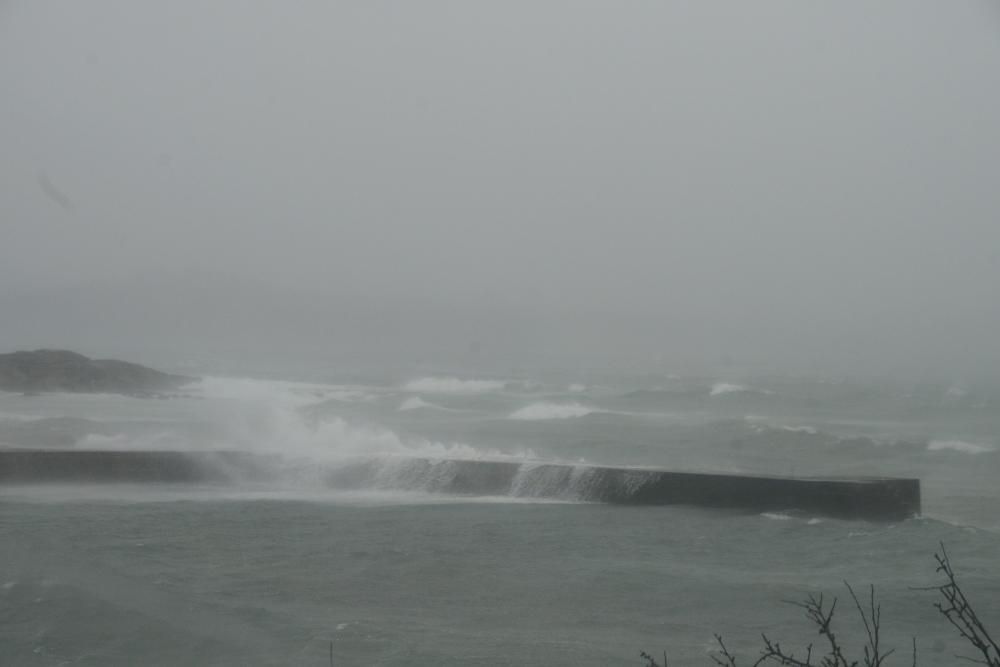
[0,350,196,396]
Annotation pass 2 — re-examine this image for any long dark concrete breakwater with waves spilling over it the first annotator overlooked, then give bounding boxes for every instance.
[0,449,921,520]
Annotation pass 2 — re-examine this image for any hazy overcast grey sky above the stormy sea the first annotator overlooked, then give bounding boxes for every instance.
[0,0,1000,373]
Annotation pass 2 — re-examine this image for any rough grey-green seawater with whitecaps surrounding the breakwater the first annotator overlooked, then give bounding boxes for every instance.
[0,377,1000,666]
